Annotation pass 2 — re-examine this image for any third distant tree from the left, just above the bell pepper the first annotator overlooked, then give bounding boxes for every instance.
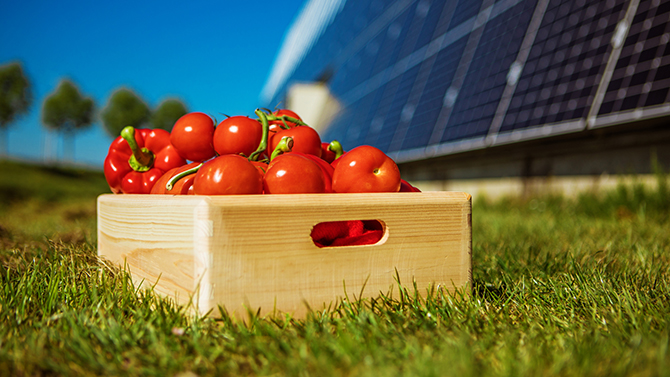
[101,88,151,138]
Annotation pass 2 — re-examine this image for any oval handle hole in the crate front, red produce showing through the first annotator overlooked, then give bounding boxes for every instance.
[310,220,388,248]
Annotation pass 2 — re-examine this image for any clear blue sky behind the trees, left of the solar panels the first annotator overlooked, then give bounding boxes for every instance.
[0,0,304,168]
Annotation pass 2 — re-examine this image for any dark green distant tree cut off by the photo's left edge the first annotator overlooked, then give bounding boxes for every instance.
[0,63,33,156]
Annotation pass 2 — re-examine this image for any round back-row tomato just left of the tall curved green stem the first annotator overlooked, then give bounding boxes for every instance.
[213,115,263,156]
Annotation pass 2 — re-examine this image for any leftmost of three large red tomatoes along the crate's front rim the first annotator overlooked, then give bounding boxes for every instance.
[193,154,263,195]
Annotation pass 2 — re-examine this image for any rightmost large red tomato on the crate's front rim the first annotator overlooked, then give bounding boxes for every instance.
[333,145,400,192]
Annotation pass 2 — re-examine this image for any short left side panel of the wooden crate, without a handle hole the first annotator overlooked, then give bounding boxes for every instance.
[98,195,203,304]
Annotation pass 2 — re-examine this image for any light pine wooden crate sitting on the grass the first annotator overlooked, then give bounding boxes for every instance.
[98,192,472,318]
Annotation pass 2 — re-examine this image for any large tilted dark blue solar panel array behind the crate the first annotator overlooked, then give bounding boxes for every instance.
[270,0,670,162]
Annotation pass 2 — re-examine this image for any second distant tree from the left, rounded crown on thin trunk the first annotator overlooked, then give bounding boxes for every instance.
[42,79,95,161]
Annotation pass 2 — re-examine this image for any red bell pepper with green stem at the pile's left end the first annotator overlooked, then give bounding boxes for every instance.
[104,126,186,194]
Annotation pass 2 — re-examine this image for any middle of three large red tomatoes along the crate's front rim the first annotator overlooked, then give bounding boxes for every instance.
[263,153,326,194]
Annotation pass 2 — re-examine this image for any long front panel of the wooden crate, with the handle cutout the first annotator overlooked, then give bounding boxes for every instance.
[195,193,471,316]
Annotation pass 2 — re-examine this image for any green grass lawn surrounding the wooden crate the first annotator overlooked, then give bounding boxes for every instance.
[0,162,670,376]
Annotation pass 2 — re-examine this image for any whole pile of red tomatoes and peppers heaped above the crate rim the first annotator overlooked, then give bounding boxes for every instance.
[104,109,419,195]
